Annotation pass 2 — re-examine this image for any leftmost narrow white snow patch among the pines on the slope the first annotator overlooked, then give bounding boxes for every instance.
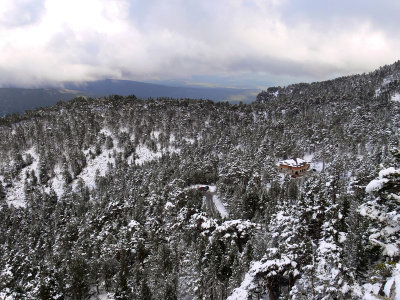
[6,147,39,207]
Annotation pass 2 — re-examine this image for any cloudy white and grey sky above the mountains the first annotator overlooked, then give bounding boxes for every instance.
[0,0,400,88]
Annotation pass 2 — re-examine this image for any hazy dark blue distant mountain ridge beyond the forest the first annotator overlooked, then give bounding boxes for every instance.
[0,79,258,116]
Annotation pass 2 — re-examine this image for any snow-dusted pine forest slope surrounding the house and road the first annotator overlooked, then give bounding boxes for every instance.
[0,64,400,299]
